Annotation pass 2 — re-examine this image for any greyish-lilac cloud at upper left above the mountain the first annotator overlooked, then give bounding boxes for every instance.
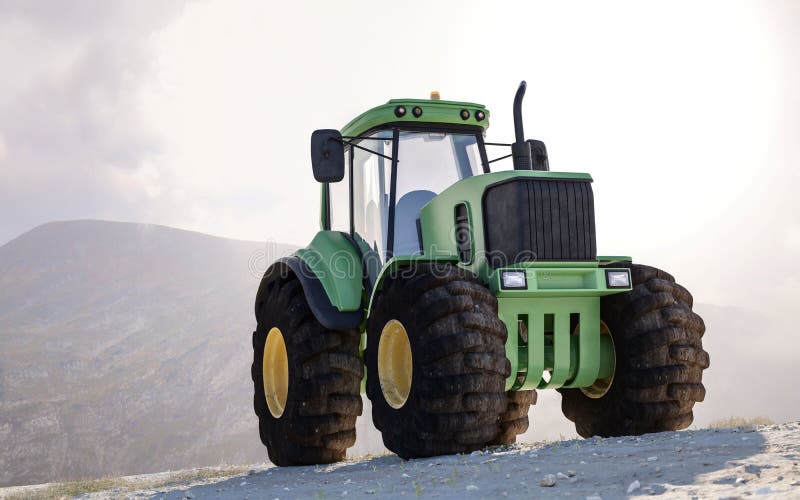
[0,1,180,244]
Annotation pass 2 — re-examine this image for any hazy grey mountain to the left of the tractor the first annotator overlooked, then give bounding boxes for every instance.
[0,221,292,485]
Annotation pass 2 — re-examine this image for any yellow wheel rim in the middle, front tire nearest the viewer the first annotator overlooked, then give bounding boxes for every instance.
[378,319,413,409]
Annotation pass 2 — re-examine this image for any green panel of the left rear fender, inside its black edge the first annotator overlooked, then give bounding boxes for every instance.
[295,231,363,311]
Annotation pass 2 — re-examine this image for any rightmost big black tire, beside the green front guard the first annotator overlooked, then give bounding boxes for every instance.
[560,264,709,437]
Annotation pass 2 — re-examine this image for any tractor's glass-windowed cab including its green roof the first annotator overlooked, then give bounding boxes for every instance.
[312,99,489,270]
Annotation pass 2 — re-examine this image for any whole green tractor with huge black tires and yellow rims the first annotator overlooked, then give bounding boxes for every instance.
[252,82,709,465]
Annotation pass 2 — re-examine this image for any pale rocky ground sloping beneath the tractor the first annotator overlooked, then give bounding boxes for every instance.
[0,422,800,499]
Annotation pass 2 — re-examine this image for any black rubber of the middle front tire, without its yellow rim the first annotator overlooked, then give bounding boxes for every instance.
[366,265,511,459]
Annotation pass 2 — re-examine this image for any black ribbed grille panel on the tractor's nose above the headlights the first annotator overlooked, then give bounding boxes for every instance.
[483,178,597,267]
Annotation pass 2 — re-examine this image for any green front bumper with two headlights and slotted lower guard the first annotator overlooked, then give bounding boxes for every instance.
[489,263,631,390]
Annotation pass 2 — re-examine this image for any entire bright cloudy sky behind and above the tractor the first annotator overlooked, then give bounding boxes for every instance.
[0,0,800,319]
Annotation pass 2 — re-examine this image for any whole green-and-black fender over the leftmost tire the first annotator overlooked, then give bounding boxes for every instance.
[256,231,363,330]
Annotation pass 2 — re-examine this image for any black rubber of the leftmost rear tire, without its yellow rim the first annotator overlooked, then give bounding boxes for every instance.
[251,275,363,466]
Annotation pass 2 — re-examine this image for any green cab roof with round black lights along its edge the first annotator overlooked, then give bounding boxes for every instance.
[342,99,489,136]
